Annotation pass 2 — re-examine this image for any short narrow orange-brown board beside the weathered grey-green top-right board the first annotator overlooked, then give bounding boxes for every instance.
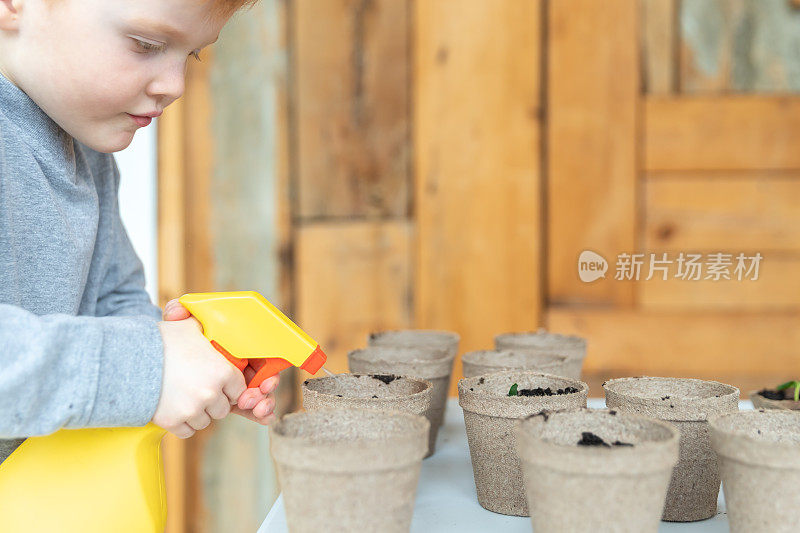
[640,0,679,94]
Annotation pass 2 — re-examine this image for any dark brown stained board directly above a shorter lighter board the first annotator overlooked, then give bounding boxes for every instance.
[292,0,410,219]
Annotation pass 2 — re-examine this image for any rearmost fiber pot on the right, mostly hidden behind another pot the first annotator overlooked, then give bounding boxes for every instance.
[494,328,586,379]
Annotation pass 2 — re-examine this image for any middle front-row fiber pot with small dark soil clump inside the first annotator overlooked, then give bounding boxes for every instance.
[516,409,679,533]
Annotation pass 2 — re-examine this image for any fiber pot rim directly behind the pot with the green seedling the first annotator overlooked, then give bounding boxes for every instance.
[461,350,569,378]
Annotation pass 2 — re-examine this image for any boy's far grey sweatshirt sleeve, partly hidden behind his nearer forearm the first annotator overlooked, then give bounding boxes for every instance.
[97,155,161,320]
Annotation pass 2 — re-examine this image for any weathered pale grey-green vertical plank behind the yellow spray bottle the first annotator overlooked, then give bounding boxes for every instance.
[197,0,294,533]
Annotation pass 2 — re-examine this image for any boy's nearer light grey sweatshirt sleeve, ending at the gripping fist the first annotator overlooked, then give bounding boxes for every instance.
[0,304,163,438]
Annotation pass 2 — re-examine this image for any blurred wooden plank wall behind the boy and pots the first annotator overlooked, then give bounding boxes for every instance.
[115,0,800,533]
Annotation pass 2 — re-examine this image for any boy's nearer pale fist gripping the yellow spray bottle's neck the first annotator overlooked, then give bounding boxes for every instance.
[153,317,246,438]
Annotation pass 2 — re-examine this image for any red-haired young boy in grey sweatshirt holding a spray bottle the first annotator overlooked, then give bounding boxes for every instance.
[0,0,278,461]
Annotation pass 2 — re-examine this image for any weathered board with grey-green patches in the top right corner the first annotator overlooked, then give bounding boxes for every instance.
[679,0,800,94]
